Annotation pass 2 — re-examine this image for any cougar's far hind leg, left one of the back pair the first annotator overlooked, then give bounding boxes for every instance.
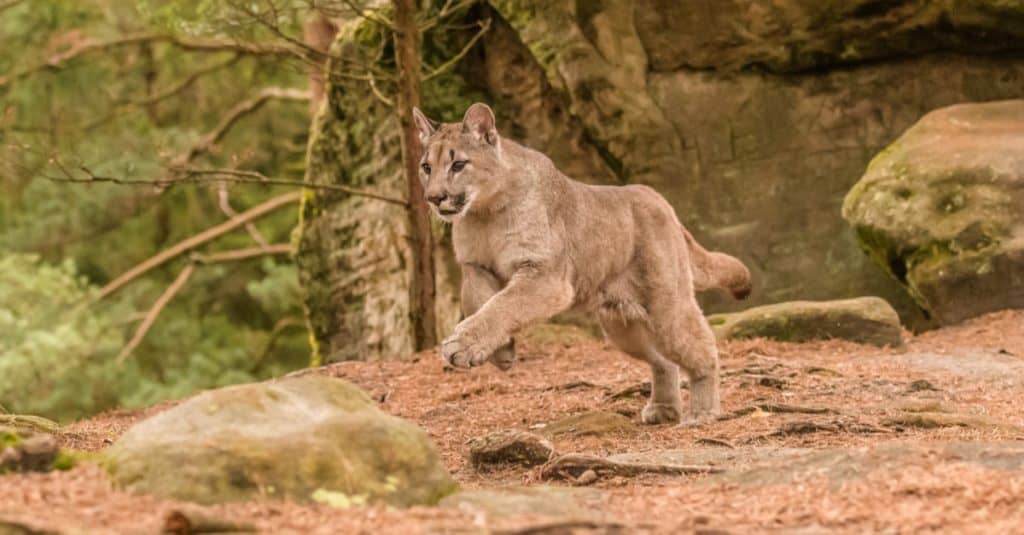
[601,318,683,423]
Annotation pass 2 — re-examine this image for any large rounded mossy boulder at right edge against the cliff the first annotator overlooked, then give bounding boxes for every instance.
[843,100,1024,324]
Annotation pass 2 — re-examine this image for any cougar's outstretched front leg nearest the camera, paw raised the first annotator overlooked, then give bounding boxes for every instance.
[441,268,572,368]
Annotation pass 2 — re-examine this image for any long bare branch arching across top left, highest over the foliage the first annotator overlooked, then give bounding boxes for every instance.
[0,34,306,88]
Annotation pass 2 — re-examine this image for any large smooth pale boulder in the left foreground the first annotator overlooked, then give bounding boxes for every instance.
[105,375,457,506]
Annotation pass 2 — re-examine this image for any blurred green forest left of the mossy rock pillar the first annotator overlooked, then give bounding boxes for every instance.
[0,0,310,419]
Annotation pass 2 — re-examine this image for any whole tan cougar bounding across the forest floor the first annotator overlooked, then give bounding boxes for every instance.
[415,104,751,423]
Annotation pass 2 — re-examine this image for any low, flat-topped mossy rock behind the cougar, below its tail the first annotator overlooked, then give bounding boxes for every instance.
[708,297,903,345]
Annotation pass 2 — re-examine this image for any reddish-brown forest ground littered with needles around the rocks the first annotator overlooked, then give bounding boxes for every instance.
[0,312,1024,534]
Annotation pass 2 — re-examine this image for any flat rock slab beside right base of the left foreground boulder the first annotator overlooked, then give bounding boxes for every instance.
[440,485,602,519]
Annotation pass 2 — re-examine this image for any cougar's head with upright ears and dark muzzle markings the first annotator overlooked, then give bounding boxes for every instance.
[413,102,503,221]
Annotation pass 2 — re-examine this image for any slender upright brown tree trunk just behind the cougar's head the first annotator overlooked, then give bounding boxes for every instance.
[393,0,437,351]
